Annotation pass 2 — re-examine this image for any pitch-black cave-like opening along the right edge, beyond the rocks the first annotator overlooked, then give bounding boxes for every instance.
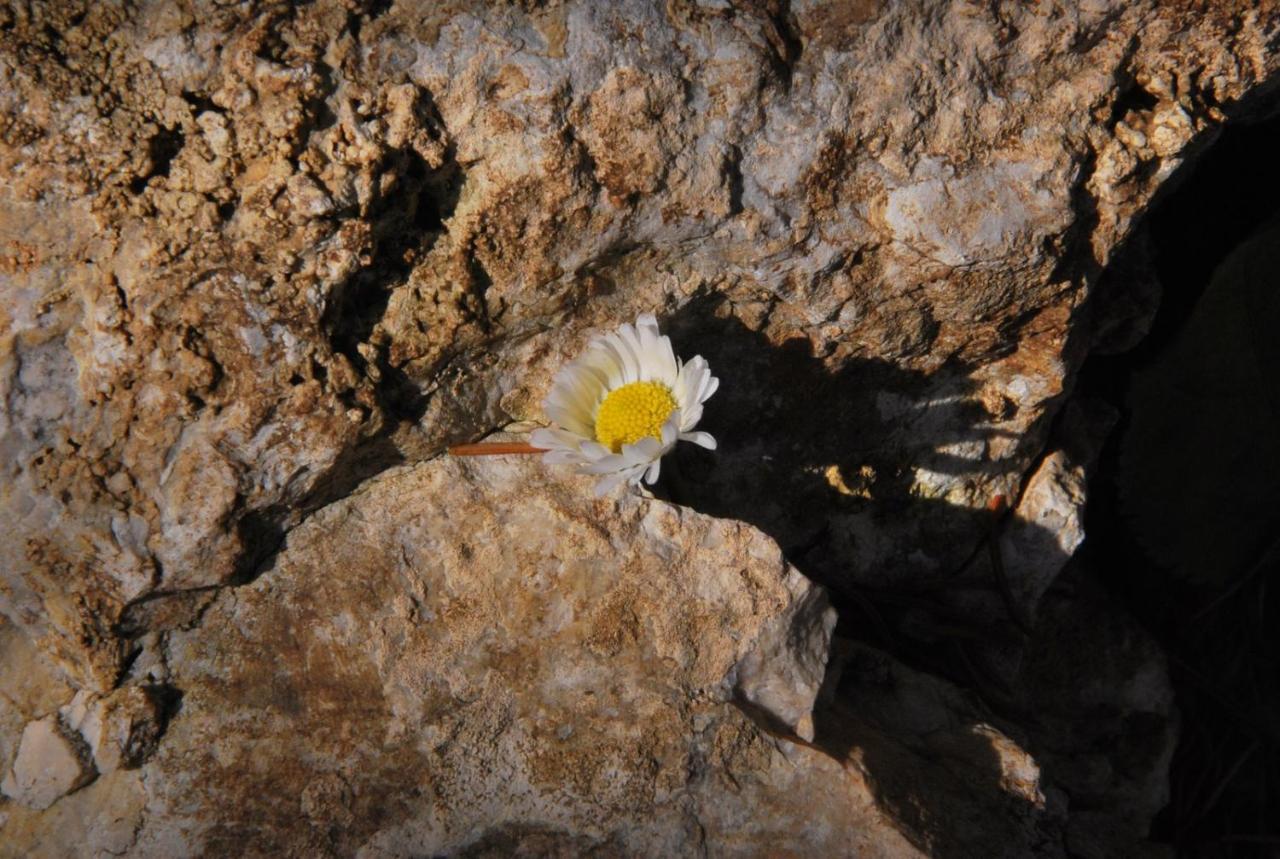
[1075,104,1280,858]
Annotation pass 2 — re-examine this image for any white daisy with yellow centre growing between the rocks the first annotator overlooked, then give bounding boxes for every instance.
[530,314,719,495]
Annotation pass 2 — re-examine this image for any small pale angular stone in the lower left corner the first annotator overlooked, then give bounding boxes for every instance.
[0,716,97,810]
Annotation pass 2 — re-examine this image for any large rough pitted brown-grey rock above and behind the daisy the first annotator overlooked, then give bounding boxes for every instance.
[0,0,1276,694]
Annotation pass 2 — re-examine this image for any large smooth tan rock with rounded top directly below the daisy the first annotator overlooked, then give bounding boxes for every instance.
[124,458,874,855]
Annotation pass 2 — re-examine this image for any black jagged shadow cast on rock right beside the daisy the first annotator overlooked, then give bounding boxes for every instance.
[659,294,1018,660]
